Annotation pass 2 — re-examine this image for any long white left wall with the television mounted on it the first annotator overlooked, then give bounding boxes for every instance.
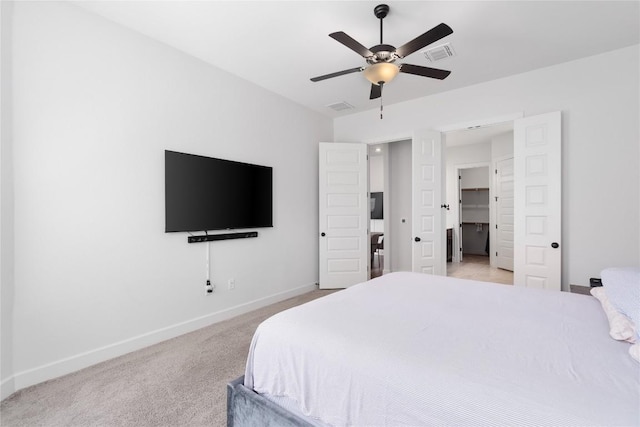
[2,2,333,398]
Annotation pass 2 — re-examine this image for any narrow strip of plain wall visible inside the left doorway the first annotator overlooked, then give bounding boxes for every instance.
[385,140,412,271]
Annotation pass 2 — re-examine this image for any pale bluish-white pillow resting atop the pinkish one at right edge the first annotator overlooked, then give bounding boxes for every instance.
[600,267,640,338]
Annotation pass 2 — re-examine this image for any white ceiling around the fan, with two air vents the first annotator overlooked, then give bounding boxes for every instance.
[74,0,640,117]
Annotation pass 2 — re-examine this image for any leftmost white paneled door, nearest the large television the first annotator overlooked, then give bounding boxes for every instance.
[319,142,370,289]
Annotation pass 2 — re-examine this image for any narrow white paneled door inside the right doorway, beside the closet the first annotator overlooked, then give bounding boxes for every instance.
[495,157,514,271]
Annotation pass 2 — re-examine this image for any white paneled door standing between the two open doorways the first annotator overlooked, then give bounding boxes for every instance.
[412,130,447,275]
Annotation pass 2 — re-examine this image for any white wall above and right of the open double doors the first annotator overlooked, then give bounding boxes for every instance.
[334,45,640,289]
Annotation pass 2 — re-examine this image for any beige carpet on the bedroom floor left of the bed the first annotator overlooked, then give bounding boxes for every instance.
[0,290,331,427]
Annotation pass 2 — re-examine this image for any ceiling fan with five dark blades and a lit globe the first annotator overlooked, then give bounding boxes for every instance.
[311,4,453,99]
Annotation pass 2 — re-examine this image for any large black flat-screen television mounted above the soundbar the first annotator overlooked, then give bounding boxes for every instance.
[164,150,273,233]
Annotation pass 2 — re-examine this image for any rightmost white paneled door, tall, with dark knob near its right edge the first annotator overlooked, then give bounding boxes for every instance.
[513,111,562,291]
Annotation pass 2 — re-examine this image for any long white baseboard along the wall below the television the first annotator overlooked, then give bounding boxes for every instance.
[7,283,317,399]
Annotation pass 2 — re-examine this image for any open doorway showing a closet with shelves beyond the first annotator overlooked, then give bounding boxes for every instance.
[445,121,513,284]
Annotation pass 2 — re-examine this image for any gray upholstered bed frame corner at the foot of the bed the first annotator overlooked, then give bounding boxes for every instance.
[227,375,313,427]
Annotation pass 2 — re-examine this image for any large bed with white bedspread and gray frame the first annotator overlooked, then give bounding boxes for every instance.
[228,273,640,427]
